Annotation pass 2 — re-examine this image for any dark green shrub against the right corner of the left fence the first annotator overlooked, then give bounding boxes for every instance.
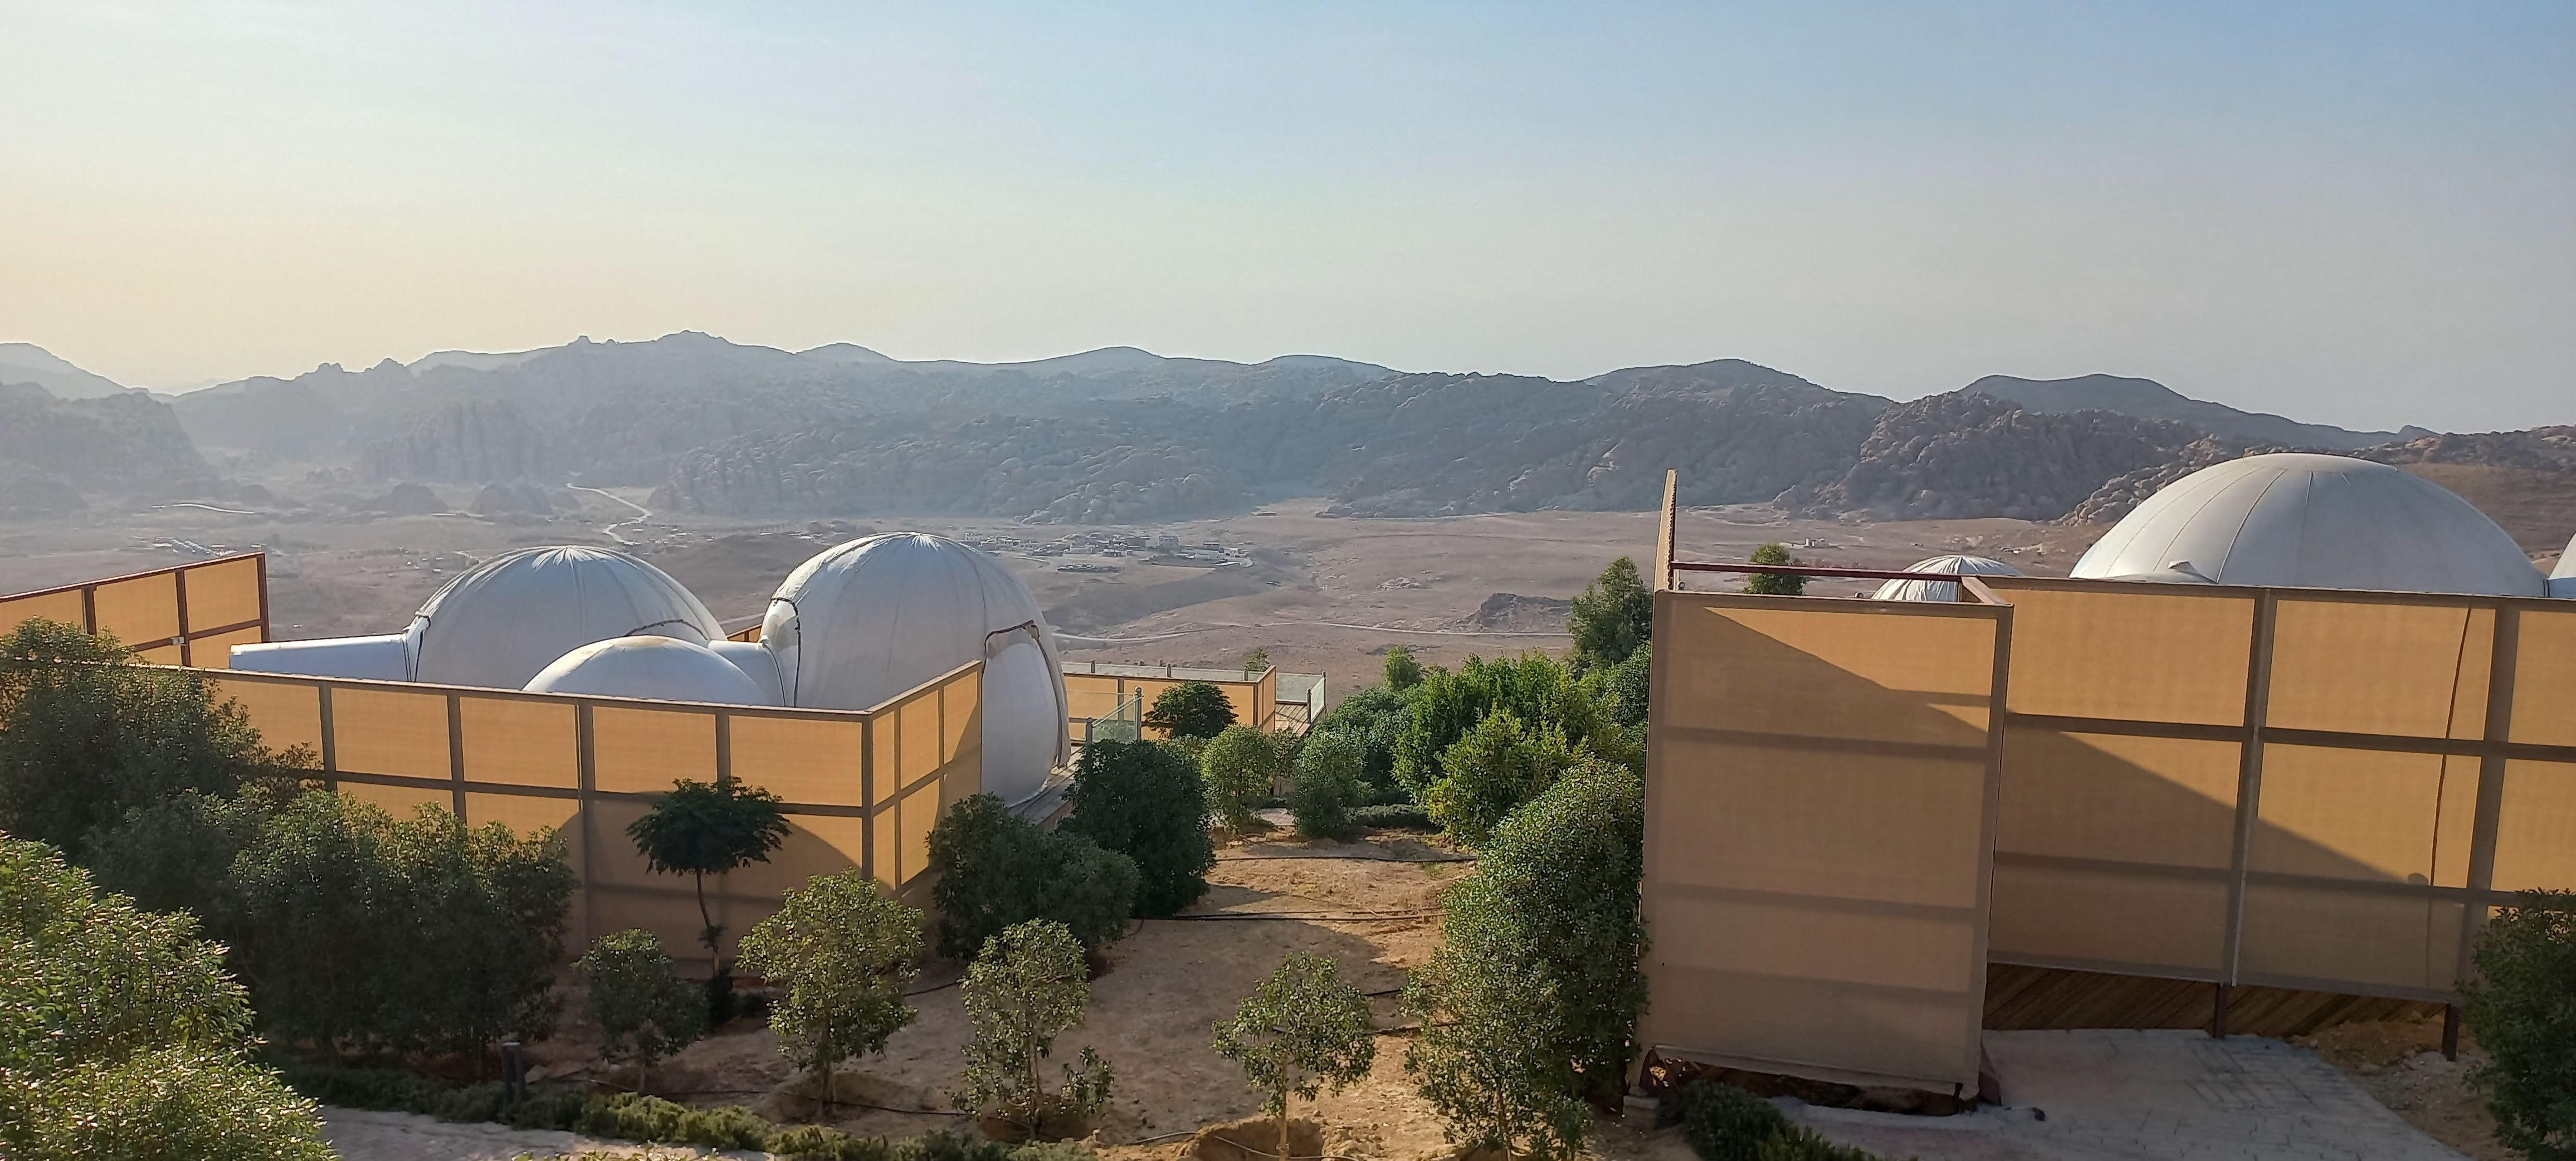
[930,796,1139,958]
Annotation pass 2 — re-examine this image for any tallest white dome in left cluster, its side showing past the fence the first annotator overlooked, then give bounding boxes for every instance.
[760,533,1069,803]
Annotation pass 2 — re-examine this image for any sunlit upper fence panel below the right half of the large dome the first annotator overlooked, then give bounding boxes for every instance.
[2267,604,2496,739]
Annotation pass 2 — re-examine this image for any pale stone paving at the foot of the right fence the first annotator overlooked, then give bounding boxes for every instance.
[1793,1030,2463,1161]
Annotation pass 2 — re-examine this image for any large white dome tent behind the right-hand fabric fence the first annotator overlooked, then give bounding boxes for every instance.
[2074,453,2548,597]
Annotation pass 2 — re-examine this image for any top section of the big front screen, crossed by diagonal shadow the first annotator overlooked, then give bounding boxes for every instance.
[1656,602,1994,747]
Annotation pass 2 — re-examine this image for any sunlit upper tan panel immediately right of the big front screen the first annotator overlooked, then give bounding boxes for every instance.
[1986,577,2254,726]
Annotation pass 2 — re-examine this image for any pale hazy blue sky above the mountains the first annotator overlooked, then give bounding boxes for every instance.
[0,0,2576,427]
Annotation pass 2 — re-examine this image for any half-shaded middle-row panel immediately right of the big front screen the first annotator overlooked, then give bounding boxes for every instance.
[1994,729,2241,870]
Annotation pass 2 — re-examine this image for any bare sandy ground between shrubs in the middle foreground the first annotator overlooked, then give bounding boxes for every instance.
[515,834,1468,1161]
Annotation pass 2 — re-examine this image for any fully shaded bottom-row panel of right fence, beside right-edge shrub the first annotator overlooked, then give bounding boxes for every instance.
[2238,878,2460,994]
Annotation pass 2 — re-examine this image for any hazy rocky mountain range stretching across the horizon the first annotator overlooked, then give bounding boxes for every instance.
[0,332,2576,535]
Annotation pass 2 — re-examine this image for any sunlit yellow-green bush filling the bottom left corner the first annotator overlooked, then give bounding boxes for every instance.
[0,839,332,1161]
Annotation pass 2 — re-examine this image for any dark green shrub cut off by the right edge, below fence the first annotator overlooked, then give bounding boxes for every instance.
[2463,891,2576,1161]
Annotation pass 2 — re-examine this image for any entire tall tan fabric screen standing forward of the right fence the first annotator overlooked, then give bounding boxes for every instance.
[1638,587,2012,1094]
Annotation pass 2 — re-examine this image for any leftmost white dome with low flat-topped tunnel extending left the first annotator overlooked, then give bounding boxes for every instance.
[232,546,724,690]
